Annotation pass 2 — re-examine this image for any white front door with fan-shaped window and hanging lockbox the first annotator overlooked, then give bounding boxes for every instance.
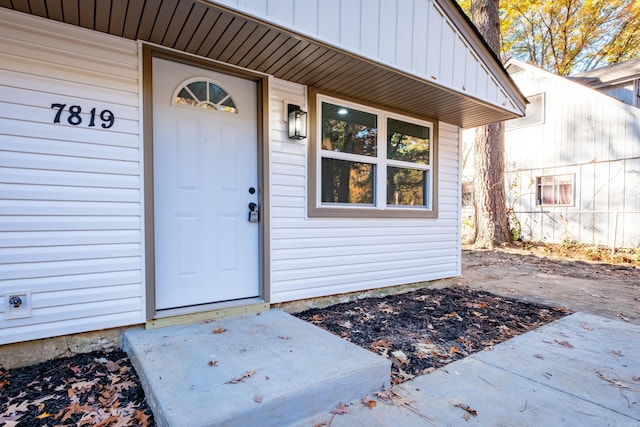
[153,58,259,311]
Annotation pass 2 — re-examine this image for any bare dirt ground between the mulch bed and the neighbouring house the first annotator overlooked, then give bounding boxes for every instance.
[457,248,640,324]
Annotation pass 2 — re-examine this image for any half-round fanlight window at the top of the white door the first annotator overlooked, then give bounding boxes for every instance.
[173,78,238,113]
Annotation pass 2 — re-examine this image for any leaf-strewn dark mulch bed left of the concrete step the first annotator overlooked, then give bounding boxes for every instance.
[0,351,155,427]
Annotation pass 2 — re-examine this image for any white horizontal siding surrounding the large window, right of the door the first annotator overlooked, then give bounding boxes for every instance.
[269,79,460,302]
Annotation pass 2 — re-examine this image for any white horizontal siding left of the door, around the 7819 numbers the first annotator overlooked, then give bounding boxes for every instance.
[0,9,144,344]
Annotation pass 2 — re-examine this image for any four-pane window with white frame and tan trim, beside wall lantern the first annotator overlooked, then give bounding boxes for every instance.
[311,94,435,221]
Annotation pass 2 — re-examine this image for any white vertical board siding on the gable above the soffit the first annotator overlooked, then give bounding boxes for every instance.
[216,0,519,114]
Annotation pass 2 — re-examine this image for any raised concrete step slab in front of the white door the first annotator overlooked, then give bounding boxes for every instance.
[123,310,391,427]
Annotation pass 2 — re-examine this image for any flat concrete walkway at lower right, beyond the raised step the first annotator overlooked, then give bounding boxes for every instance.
[294,313,640,427]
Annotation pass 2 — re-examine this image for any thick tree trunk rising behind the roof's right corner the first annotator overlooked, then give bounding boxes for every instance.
[471,0,511,248]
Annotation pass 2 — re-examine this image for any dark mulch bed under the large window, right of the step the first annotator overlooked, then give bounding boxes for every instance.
[296,286,570,384]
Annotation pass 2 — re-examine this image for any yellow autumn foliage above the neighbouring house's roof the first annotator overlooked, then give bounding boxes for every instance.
[458,0,640,75]
